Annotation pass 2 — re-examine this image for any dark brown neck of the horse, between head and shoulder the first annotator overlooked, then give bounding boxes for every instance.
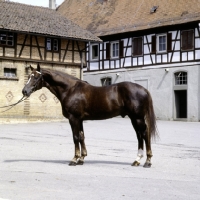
[43,70,73,99]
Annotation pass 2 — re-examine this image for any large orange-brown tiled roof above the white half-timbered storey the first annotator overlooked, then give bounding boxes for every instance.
[57,0,200,36]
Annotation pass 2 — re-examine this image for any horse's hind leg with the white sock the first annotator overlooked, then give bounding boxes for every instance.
[131,118,144,166]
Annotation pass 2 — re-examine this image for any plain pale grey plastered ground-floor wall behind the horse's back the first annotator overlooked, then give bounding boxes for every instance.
[84,65,200,121]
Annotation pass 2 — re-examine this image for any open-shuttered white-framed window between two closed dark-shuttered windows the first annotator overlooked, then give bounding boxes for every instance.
[151,33,172,53]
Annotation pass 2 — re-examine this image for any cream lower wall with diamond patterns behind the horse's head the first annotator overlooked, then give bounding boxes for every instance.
[0,59,80,122]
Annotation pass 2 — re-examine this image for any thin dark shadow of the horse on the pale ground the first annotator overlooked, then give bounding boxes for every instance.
[4,159,131,165]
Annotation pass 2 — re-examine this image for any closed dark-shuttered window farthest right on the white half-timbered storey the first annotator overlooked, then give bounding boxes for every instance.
[181,30,194,50]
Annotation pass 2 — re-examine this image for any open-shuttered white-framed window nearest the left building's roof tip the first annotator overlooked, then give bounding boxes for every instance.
[106,40,124,60]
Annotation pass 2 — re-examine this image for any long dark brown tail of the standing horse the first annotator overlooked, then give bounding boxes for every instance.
[145,91,159,140]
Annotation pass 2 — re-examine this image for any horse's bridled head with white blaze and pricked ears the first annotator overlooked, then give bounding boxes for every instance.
[22,64,42,97]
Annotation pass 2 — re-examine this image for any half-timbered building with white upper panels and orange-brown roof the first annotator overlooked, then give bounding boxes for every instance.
[58,0,200,121]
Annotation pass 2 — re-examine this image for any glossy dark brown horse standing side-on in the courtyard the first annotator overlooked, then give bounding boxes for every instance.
[22,64,157,167]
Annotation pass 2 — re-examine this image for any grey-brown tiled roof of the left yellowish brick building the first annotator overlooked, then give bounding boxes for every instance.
[0,1,100,41]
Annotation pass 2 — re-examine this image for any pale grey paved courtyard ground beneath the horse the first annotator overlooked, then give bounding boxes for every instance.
[0,118,200,200]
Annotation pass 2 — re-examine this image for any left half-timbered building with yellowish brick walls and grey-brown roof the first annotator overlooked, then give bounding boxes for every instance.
[0,1,100,121]
